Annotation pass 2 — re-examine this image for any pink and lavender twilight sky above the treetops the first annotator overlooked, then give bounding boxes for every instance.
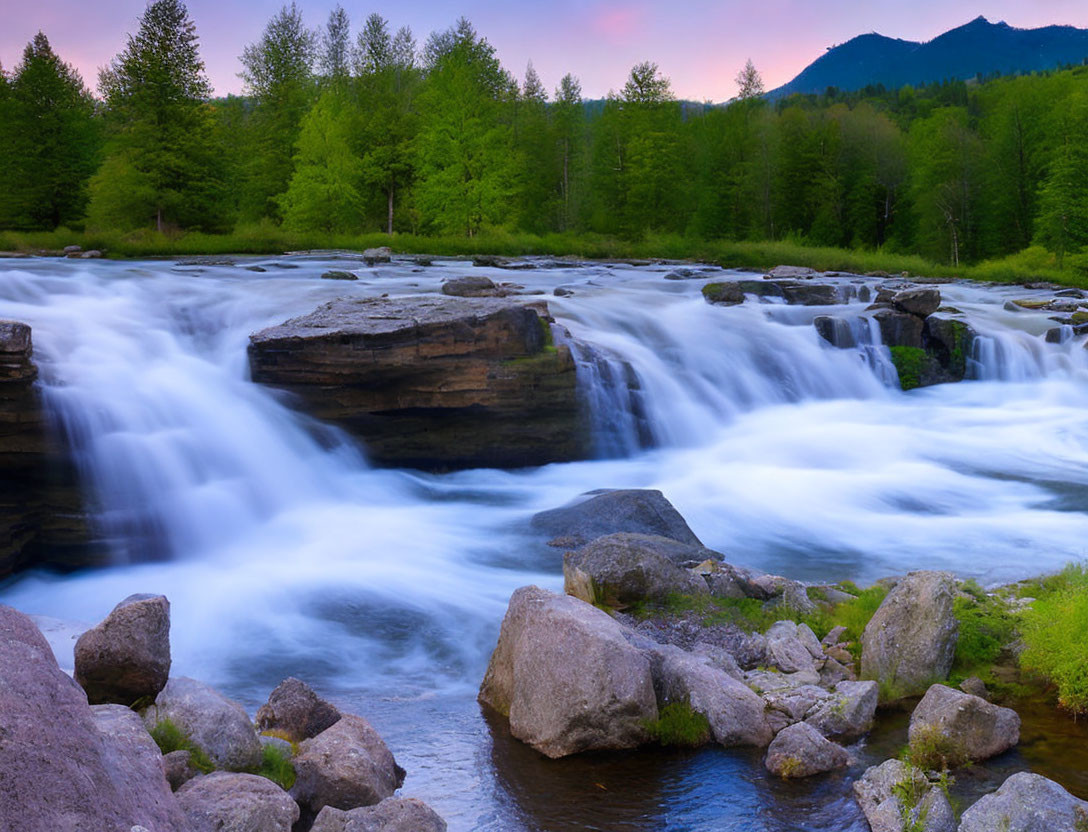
[0,0,1088,101]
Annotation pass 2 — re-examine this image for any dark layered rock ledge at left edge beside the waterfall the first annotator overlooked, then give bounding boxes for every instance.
[0,321,94,579]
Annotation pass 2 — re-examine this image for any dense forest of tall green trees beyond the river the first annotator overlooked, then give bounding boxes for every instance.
[0,0,1088,266]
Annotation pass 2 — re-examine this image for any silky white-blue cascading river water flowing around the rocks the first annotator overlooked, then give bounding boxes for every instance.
[0,258,1088,830]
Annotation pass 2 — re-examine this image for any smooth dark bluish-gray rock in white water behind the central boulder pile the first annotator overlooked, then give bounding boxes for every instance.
[530,482,703,548]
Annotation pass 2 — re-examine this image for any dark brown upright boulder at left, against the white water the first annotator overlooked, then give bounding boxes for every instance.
[75,595,170,705]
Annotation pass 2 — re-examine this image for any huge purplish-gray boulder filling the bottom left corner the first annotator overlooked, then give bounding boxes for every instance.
[0,606,188,832]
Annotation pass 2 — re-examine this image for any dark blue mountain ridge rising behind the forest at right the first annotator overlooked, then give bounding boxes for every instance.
[767,17,1088,99]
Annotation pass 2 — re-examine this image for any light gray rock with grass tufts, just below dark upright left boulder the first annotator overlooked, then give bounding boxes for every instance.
[144,676,261,771]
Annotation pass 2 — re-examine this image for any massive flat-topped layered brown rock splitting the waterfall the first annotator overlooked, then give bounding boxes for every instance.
[249,296,589,469]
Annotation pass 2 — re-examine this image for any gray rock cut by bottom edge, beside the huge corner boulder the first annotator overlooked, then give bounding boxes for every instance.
[177,771,299,832]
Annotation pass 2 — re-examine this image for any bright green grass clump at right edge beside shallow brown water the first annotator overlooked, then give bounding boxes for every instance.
[1021,563,1088,715]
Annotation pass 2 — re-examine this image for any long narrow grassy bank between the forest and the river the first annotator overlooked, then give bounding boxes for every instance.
[0,224,1088,287]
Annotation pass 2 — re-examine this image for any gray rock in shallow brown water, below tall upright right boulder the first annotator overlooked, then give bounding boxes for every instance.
[908,685,1019,762]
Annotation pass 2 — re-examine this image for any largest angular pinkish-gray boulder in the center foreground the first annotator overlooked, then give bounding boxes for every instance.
[479,586,657,757]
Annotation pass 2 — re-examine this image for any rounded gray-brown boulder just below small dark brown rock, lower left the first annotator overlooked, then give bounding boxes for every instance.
[290,713,405,815]
